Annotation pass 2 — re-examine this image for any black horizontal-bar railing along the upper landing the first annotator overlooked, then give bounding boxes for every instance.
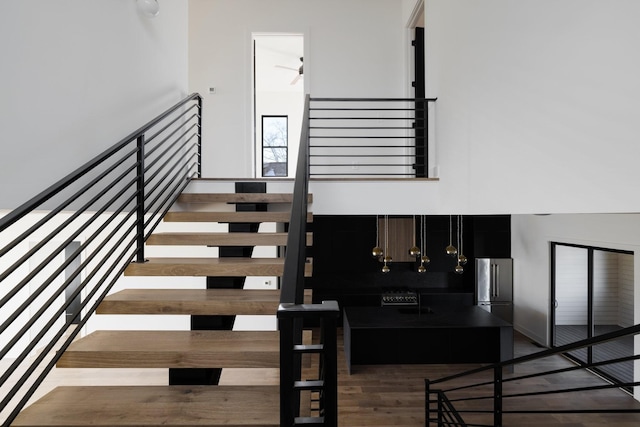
[309,98,436,178]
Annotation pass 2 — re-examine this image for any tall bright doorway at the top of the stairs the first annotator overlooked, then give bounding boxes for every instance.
[253,33,306,178]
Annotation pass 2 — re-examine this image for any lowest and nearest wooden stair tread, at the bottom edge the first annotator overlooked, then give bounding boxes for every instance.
[12,386,280,427]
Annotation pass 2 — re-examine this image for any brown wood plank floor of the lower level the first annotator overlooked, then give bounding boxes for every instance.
[10,331,640,427]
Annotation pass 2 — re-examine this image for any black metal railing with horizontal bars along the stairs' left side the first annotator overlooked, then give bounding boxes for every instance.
[0,94,202,426]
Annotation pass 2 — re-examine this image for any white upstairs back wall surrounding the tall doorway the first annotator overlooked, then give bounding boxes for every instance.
[189,0,406,177]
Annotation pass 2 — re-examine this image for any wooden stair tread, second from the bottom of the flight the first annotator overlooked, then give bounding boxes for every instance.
[56,330,296,368]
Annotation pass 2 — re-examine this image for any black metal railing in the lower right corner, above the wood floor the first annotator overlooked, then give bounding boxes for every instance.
[425,324,640,426]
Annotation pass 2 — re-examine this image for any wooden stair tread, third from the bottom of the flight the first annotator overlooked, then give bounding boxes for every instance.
[96,289,311,316]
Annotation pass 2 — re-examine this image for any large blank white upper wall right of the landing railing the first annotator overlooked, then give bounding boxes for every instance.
[426,0,640,213]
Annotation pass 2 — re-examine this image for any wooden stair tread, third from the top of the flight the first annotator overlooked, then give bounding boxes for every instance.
[146,232,313,246]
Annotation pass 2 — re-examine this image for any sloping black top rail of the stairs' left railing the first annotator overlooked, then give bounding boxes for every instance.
[0,93,201,232]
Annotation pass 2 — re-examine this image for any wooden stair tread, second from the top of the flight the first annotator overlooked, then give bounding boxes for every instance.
[164,211,313,223]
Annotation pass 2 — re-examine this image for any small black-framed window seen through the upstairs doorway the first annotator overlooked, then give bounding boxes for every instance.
[262,116,289,176]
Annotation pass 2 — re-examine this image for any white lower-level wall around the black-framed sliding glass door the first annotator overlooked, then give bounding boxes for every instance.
[511,214,640,344]
